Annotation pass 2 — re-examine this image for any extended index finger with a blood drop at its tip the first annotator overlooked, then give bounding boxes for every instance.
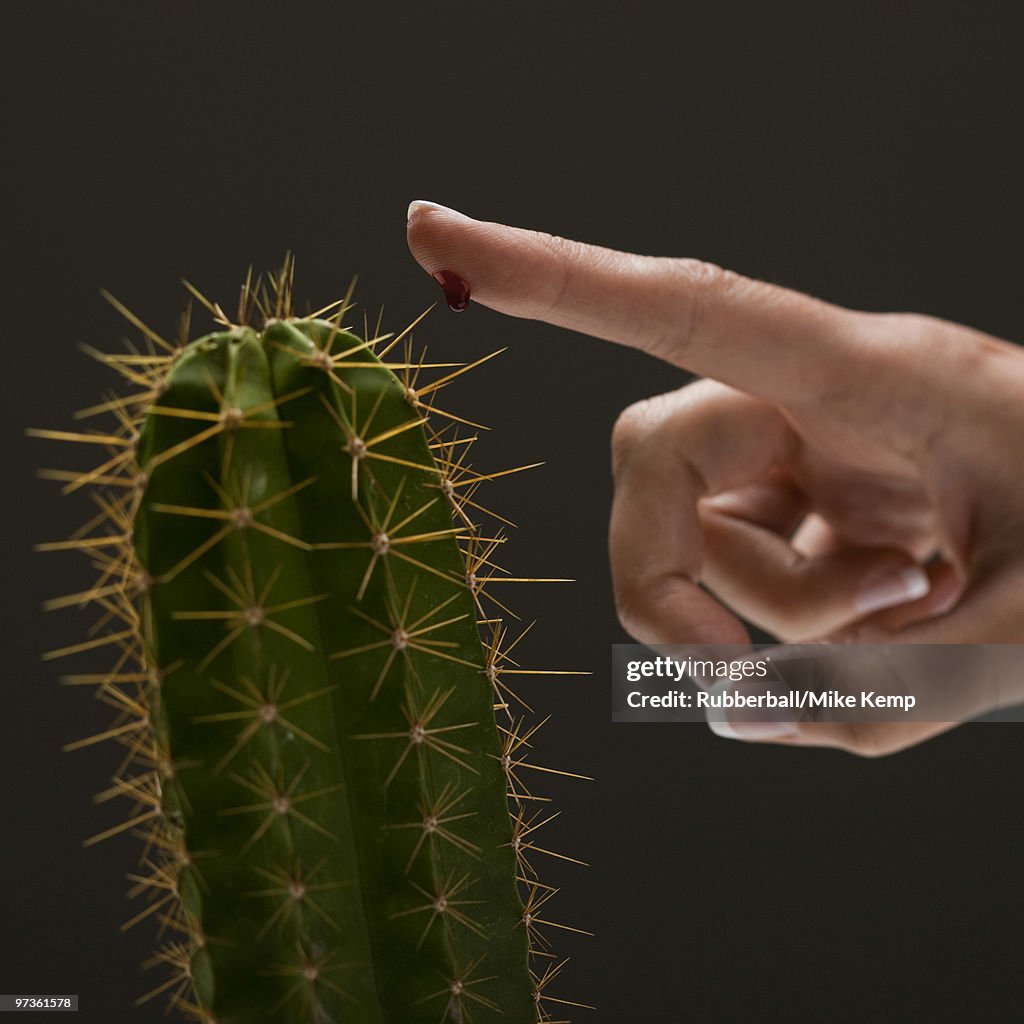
[408,201,864,402]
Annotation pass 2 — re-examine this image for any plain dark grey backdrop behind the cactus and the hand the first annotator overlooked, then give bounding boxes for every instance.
[0,0,1024,1024]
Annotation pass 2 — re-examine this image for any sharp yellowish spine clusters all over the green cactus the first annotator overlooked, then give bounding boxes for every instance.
[32,260,583,1024]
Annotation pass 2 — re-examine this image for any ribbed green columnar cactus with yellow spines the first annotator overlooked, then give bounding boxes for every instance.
[33,260,589,1024]
